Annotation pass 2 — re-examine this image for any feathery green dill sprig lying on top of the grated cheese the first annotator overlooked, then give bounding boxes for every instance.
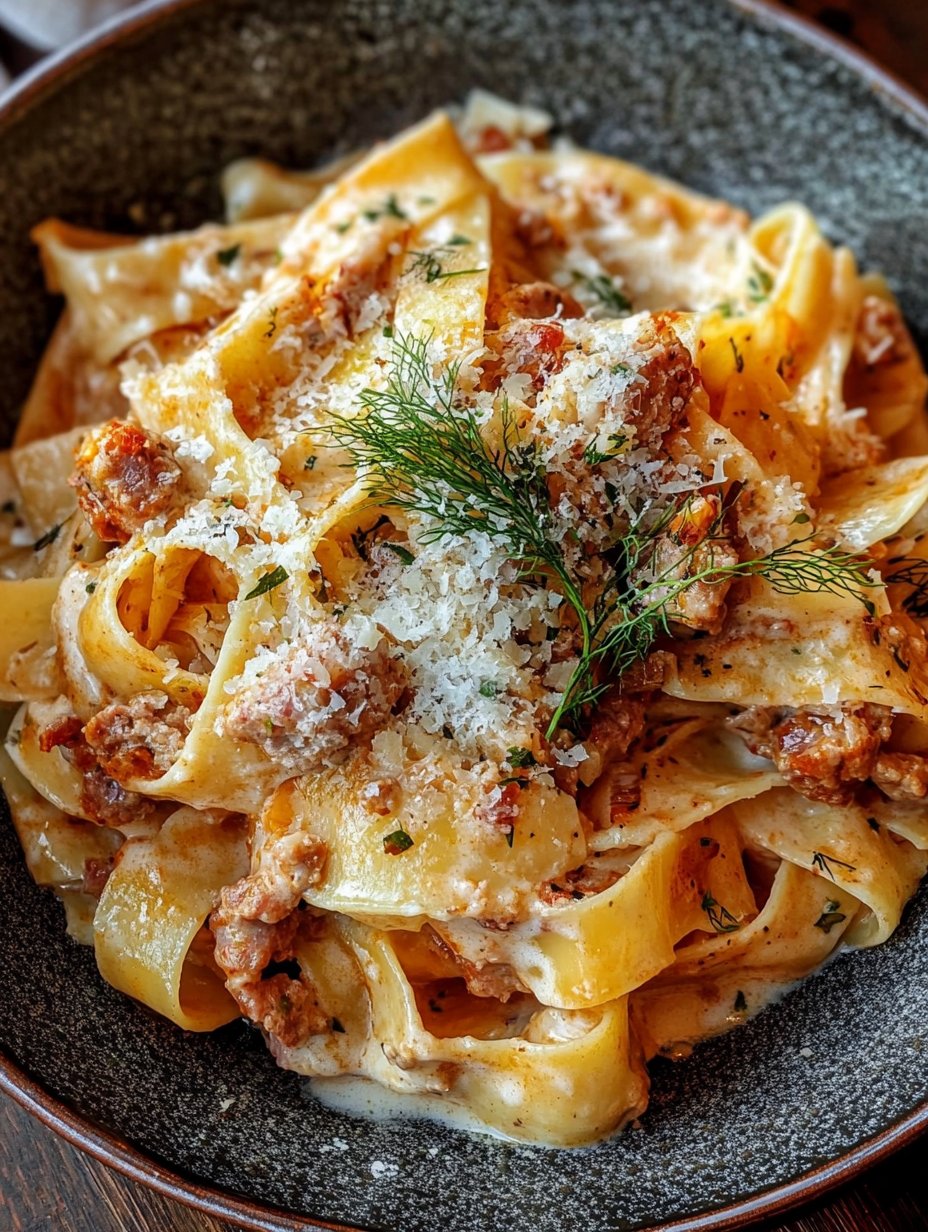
[330,335,875,739]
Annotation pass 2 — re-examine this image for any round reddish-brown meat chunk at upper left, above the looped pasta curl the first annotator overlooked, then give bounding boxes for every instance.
[70,419,184,543]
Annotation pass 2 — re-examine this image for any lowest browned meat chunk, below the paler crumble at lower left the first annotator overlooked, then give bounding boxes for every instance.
[210,887,329,1047]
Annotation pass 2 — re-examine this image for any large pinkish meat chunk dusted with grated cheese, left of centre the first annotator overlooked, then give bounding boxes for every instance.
[222,621,405,774]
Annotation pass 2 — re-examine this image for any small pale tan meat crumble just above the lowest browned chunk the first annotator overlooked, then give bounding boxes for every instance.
[223,833,329,924]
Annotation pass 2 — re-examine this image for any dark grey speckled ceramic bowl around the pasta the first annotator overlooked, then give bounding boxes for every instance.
[0,0,928,1232]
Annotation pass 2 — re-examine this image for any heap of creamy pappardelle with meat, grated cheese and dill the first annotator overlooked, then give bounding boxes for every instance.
[0,95,928,1146]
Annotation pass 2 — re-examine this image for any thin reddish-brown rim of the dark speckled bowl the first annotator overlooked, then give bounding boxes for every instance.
[0,0,928,1232]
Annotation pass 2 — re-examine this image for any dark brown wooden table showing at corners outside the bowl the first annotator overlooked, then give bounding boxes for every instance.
[0,0,928,1232]
